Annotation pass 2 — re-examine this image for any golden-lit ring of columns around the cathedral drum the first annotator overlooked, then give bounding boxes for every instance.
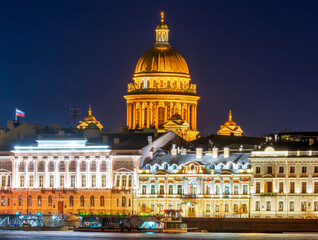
[127,101,197,130]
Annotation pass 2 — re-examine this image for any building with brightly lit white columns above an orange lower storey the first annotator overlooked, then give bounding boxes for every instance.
[0,139,140,214]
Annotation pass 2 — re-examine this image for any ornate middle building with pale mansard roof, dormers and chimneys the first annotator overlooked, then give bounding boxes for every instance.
[137,148,252,217]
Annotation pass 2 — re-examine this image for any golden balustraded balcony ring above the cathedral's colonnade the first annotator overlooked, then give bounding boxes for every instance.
[128,83,197,95]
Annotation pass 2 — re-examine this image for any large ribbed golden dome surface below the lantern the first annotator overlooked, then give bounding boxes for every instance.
[135,46,189,74]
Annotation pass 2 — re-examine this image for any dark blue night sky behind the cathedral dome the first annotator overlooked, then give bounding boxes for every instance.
[0,0,318,136]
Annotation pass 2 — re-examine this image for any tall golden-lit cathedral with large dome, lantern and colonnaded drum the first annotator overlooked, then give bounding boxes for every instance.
[124,13,200,141]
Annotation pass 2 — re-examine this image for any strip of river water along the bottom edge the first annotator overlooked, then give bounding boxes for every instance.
[0,231,318,240]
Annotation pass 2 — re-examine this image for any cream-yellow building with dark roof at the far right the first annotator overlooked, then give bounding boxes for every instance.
[250,134,318,218]
